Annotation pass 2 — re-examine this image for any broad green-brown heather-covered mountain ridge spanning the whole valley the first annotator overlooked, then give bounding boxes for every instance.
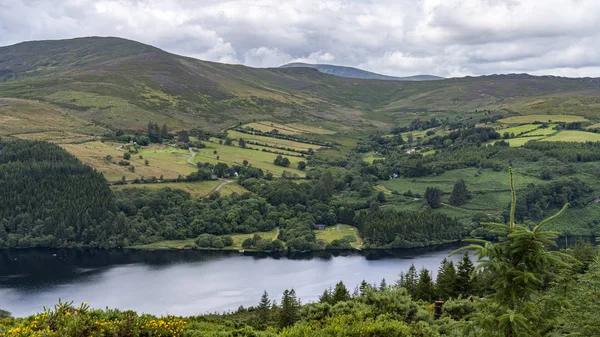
[0,37,600,132]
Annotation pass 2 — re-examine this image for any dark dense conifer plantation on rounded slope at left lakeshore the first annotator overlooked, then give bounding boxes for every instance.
[0,140,117,247]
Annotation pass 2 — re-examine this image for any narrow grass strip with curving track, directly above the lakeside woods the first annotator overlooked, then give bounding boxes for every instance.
[111,180,239,198]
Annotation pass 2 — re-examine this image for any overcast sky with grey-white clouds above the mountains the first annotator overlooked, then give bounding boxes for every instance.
[0,0,600,77]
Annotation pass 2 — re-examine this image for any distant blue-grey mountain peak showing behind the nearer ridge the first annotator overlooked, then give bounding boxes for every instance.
[280,62,444,81]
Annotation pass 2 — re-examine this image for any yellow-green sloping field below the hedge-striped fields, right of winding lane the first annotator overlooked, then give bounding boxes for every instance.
[194,138,306,177]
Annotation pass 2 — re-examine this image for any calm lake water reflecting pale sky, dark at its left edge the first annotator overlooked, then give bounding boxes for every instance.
[0,245,460,316]
